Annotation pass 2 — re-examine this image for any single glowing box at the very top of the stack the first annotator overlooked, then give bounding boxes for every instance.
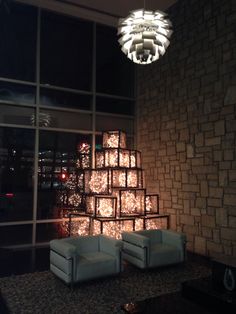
[102,131,126,148]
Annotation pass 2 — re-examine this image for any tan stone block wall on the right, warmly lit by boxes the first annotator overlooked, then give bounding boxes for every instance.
[137,0,236,256]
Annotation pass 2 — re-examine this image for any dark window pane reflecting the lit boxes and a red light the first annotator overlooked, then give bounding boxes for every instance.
[37,131,91,219]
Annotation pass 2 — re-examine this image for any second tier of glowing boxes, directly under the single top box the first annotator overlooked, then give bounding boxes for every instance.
[95,148,141,168]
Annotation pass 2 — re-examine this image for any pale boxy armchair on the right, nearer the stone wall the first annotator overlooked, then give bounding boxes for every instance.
[122,229,186,268]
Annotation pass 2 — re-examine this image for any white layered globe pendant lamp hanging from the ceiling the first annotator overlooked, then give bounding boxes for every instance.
[118,5,172,64]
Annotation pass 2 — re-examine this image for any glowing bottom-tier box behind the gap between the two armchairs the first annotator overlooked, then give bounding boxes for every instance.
[91,218,134,239]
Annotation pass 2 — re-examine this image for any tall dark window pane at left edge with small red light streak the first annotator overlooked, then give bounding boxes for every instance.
[0,128,34,221]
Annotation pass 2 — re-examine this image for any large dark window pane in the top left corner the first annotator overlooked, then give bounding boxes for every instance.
[0,1,37,81]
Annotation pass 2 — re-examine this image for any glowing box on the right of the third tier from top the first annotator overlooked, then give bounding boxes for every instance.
[111,169,143,188]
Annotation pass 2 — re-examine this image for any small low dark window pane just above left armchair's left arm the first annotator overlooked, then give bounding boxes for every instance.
[36,222,68,242]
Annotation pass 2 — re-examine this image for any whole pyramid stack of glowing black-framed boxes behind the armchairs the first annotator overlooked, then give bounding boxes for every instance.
[62,131,168,238]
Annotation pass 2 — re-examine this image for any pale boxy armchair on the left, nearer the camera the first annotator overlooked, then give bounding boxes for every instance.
[50,235,122,285]
